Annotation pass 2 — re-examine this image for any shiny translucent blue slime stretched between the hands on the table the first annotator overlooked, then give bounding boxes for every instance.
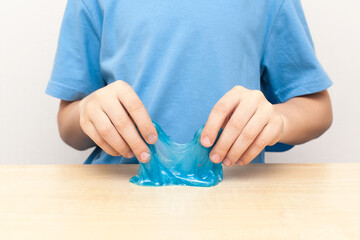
[130,122,223,187]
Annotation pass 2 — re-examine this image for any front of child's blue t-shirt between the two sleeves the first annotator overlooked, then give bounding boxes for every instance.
[86,0,281,163]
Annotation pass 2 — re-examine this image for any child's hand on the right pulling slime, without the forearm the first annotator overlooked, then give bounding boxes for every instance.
[201,86,284,166]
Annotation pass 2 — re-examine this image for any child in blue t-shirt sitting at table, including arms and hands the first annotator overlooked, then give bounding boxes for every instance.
[46,0,332,166]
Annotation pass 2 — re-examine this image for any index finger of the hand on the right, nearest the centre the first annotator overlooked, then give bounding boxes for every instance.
[201,88,239,148]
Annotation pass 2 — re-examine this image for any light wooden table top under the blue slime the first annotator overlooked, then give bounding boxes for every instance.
[0,164,360,240]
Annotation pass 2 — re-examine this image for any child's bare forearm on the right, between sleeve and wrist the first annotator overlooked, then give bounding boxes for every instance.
[275,91,332,145]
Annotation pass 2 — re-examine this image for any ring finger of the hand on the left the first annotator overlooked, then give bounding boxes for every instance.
[91,110,134,158]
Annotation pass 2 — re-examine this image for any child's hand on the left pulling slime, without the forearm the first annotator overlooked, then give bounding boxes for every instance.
[79,80,157,162]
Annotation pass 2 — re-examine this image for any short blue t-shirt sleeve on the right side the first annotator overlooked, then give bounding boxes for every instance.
[261,0,332,103]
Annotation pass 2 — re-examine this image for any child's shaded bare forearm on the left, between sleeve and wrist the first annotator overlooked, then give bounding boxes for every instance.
[58,101,95,150]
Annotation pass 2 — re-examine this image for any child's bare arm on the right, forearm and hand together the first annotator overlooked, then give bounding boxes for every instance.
[201,86,332,166]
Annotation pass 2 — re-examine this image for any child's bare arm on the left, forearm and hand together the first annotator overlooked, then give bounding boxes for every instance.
[58,81,157,162]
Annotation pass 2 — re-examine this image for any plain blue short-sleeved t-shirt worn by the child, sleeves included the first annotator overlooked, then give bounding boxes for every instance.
[46,0,331,164]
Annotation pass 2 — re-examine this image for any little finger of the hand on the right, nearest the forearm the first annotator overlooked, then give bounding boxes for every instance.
[237,119,281,166]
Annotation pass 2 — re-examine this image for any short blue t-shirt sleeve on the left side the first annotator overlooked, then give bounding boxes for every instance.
[46,0,105,101]
